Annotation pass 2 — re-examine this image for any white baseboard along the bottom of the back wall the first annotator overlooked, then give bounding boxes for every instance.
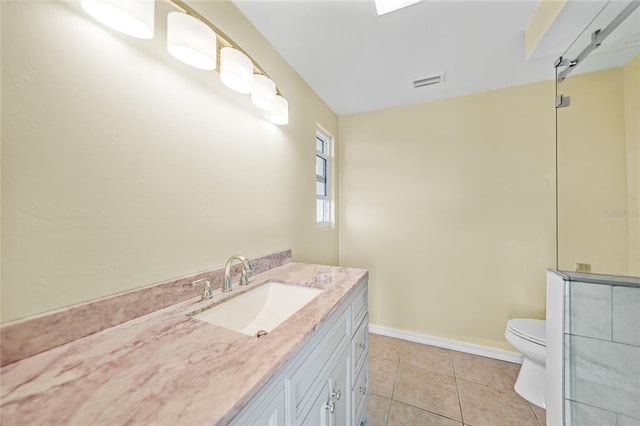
[369,324,522,364]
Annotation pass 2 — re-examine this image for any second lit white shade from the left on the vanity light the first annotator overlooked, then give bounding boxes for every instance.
[167,12,218,70]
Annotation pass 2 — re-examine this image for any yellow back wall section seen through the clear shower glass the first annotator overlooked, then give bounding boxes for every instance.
[558,67,629,275]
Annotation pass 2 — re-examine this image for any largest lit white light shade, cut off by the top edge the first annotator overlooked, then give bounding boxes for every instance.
[82,0,155,39]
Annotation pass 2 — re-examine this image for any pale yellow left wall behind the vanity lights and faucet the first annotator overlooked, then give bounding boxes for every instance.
[1,1,338,321]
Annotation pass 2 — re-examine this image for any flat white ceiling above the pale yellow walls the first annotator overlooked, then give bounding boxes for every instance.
[234,0,628,115]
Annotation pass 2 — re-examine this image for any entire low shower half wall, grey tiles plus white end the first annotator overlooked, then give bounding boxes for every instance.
[545,270,640,426]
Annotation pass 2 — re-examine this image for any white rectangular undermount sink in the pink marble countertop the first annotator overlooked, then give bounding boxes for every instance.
[193,281,322,336]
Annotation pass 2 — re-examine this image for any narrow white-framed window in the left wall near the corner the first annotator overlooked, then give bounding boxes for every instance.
[316,129,332,228]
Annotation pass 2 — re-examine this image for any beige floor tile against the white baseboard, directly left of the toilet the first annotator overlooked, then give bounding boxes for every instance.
[451,351,516,390]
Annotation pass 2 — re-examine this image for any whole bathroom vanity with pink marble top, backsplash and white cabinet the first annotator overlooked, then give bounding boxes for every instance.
[0,252,369,426]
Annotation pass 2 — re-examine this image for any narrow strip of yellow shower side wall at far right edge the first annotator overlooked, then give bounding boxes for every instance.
[623,55,640,277]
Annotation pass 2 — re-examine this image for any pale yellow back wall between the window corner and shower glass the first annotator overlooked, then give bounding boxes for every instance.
[339,81,555,348]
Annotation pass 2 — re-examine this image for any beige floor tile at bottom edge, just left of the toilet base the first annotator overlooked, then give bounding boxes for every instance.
[457,379,538,426]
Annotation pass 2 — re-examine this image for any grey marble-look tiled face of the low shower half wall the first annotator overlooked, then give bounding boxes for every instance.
[564,281,640,426]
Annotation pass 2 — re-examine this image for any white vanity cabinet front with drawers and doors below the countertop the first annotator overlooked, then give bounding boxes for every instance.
[231,281,369,426]
